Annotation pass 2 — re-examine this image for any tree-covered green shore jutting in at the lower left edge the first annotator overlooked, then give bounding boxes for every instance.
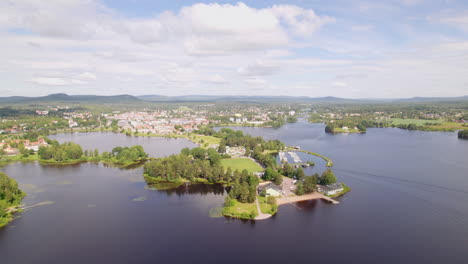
[0,172,26,227]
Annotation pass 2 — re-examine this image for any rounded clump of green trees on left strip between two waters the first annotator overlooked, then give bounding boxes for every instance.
[38,140,83,162]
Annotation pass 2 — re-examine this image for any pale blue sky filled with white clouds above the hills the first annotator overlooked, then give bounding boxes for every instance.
[0,0,468,98]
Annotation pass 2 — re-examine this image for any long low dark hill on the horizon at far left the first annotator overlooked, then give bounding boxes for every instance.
[0,93,142,104]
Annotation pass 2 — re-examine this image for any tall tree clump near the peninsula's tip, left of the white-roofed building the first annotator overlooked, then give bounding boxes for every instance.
[224,170,259,204]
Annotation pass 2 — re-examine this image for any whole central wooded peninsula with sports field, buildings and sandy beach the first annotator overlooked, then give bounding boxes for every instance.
[143,127,350,220]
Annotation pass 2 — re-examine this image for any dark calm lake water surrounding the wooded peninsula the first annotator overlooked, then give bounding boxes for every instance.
[0,122,468,264]
